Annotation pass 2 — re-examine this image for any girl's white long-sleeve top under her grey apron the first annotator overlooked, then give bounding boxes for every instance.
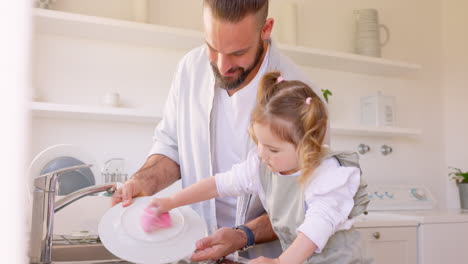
[215,149,360,253]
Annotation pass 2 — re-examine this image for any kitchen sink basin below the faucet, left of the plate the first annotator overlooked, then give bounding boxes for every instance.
[52,243,131,264]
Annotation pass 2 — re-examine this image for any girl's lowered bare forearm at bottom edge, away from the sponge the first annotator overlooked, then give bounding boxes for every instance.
[249,232,317,264]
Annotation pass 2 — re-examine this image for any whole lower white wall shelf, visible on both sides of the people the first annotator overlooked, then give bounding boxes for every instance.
[30,102,421,137]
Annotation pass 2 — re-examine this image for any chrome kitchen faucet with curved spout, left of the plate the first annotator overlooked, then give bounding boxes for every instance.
[29,164,117,264]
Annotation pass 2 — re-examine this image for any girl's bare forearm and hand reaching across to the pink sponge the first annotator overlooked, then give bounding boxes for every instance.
[149,177,219,214]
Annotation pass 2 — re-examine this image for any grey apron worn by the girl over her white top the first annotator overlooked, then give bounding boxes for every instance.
[260,152,372,264]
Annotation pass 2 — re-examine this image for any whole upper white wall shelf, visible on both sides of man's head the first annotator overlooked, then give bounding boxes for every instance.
[34,8,421,77]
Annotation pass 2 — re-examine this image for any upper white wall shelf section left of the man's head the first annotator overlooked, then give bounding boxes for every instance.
[33,8,203,50]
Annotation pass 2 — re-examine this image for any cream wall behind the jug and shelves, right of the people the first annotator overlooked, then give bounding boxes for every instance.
[298,0,445,206]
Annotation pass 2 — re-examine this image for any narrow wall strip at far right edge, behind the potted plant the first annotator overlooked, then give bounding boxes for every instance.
[442,0,468,208]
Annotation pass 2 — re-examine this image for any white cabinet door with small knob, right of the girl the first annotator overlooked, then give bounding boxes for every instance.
[357,227,417,264]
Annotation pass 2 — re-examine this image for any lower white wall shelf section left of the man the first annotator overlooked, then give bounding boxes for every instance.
[30,102,162,124]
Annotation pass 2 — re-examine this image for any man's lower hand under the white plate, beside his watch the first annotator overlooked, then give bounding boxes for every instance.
[190,227,247,261]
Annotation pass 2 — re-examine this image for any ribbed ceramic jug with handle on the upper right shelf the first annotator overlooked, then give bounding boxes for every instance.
[354,9,390,57]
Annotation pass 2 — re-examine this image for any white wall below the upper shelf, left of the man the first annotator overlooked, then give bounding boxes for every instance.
[30,35,182,177]
